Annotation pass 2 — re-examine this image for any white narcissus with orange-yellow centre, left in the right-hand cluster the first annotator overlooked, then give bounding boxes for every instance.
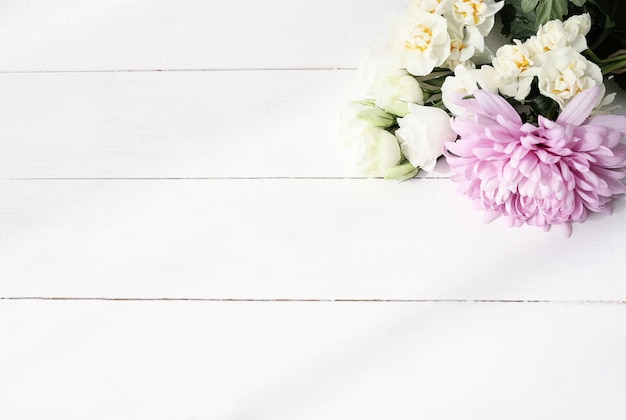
[493,40,539,101]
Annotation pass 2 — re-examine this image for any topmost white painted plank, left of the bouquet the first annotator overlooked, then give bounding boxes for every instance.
[0,0,405,71]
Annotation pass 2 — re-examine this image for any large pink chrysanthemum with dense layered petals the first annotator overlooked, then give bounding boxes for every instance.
[445,87,626,235]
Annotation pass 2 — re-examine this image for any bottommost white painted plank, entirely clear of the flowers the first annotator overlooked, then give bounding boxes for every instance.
[0,301,626,420]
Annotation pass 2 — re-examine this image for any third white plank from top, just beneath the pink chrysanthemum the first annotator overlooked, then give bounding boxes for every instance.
[0,179,626,300]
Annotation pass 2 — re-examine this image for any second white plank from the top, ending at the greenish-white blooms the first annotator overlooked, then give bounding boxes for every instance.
[0,70,456,178]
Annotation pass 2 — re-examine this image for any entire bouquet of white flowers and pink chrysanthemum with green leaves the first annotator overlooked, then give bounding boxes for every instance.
[343,0,626,234]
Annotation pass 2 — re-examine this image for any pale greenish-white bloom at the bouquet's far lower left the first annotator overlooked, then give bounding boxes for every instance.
[341,104,402,176]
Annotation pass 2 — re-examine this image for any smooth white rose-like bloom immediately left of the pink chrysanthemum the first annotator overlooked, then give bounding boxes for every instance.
[396,104,456,171]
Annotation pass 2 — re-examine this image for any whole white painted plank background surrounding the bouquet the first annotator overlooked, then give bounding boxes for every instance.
[0,0,626,420]
